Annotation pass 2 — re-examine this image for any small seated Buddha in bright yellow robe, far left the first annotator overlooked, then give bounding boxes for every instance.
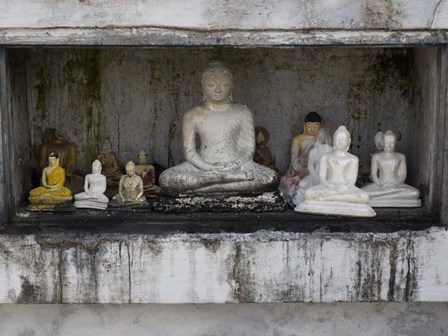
[29,152,72,204]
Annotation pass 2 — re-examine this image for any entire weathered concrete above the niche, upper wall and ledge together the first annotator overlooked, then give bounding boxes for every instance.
[0,0,448,45]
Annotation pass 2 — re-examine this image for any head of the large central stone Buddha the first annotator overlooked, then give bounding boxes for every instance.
[202,61,233,105]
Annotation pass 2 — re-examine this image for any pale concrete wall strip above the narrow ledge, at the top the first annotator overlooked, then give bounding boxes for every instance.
[0,0,448,30]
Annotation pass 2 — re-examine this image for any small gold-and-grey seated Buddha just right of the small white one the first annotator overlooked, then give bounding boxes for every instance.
[109,161,147,207]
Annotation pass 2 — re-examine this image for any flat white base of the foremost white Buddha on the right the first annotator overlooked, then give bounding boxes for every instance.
[294,201,376,217]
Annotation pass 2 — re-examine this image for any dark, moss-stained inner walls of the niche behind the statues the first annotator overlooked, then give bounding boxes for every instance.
[6,47,440,220]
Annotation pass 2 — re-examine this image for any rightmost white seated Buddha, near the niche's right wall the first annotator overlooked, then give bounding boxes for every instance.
[362,131,422,208]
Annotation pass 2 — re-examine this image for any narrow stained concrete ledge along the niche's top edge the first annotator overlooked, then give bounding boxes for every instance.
[0,27,448,47]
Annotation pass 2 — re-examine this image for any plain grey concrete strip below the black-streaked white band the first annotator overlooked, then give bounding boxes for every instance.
[0,303,448,336]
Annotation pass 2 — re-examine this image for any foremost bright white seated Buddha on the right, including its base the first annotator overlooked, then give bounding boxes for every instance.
[294,126,376,217]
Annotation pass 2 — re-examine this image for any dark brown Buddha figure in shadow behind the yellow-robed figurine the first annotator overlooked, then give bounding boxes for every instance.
[39,128,76,177]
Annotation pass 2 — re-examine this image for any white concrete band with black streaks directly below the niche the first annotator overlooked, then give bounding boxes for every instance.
[0,228,448,303]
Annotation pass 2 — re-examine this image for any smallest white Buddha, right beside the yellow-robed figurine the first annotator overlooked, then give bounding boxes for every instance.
[74,160,109,210]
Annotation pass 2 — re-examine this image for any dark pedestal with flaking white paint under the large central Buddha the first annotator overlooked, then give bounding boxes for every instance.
[152,192,287,213]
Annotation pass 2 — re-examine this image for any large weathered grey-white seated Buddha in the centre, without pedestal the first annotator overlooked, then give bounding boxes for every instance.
[159,62,278,193]
